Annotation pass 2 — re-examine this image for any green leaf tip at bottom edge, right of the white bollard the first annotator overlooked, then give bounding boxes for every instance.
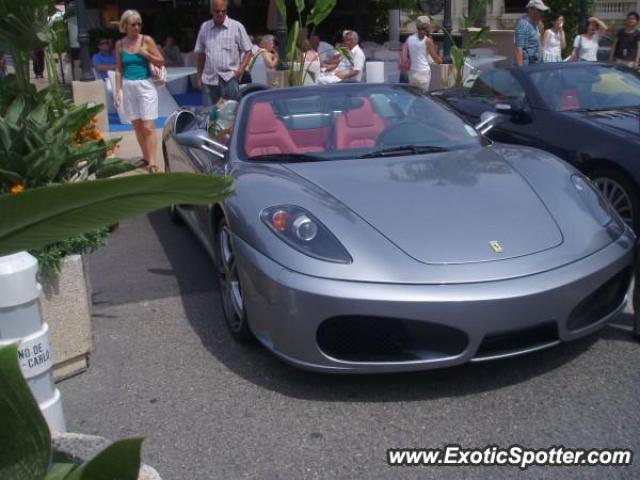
[65,438,143,480]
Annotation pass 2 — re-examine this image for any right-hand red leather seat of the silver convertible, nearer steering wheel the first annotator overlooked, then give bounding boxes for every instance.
[336,98,385,150]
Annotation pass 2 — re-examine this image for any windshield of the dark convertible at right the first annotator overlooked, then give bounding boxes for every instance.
[529,63,640,112]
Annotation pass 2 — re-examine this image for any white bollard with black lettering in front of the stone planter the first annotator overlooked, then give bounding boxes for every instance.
[0,252,67,432]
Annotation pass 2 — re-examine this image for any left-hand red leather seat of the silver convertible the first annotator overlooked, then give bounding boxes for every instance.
[244,102,299,157]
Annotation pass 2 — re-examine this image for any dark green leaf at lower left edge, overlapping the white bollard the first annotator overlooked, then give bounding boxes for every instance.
[0,344,51,479]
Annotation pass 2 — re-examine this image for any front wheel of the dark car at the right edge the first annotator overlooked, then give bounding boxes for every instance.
[589,168,640,232]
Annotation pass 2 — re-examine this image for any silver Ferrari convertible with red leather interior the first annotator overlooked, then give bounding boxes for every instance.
[162,84,634,373]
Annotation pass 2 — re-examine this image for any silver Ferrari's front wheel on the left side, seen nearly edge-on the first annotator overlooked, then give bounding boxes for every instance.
[215,217,255,344]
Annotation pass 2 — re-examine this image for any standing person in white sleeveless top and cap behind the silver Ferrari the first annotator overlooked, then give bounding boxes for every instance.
[406,15,442,92]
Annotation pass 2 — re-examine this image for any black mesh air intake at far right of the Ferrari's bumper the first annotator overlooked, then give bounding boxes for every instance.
[567,269,631,330]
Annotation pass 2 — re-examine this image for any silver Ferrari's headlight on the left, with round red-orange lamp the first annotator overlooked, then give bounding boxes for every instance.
[260,205,353,263]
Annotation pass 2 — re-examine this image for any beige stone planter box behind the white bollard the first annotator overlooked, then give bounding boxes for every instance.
[40,255,93,380]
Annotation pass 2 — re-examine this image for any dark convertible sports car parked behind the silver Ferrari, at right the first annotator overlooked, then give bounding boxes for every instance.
[435,62,640,233]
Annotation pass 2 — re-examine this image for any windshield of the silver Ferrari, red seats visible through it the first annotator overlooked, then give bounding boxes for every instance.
[237,84,483,162]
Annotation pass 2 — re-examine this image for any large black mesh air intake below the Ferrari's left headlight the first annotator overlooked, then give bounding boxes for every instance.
[317,316,468,362]
